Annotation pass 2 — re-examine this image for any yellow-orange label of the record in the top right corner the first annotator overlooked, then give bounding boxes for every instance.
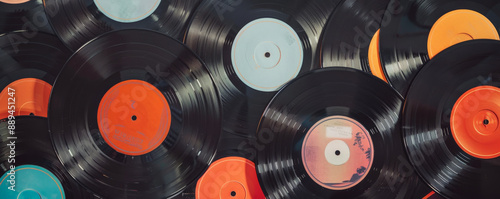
[427,9,500,59]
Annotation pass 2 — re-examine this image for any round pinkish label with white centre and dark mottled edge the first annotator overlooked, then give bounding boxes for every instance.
[302,116,373,190]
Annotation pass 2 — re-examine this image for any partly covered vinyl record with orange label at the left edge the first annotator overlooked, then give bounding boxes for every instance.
[0,31,71,118]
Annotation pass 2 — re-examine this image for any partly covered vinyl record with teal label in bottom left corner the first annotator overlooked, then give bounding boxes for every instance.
[0,116,99,199]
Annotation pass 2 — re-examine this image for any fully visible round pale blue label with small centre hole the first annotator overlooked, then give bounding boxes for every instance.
[231,18,304,92]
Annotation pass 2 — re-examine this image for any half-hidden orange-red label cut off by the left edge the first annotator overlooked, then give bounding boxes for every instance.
[0,78,52,119]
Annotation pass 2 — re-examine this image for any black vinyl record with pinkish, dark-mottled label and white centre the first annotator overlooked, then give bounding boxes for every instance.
[256,67,420,198]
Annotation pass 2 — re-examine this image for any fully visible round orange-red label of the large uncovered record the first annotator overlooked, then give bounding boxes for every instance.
[97,80,171,155]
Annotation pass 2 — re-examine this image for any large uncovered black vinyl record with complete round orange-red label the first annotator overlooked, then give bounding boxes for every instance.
[49,30,222,198]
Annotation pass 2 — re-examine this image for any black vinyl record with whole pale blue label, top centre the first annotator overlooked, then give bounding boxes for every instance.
[184,0,338,160]
